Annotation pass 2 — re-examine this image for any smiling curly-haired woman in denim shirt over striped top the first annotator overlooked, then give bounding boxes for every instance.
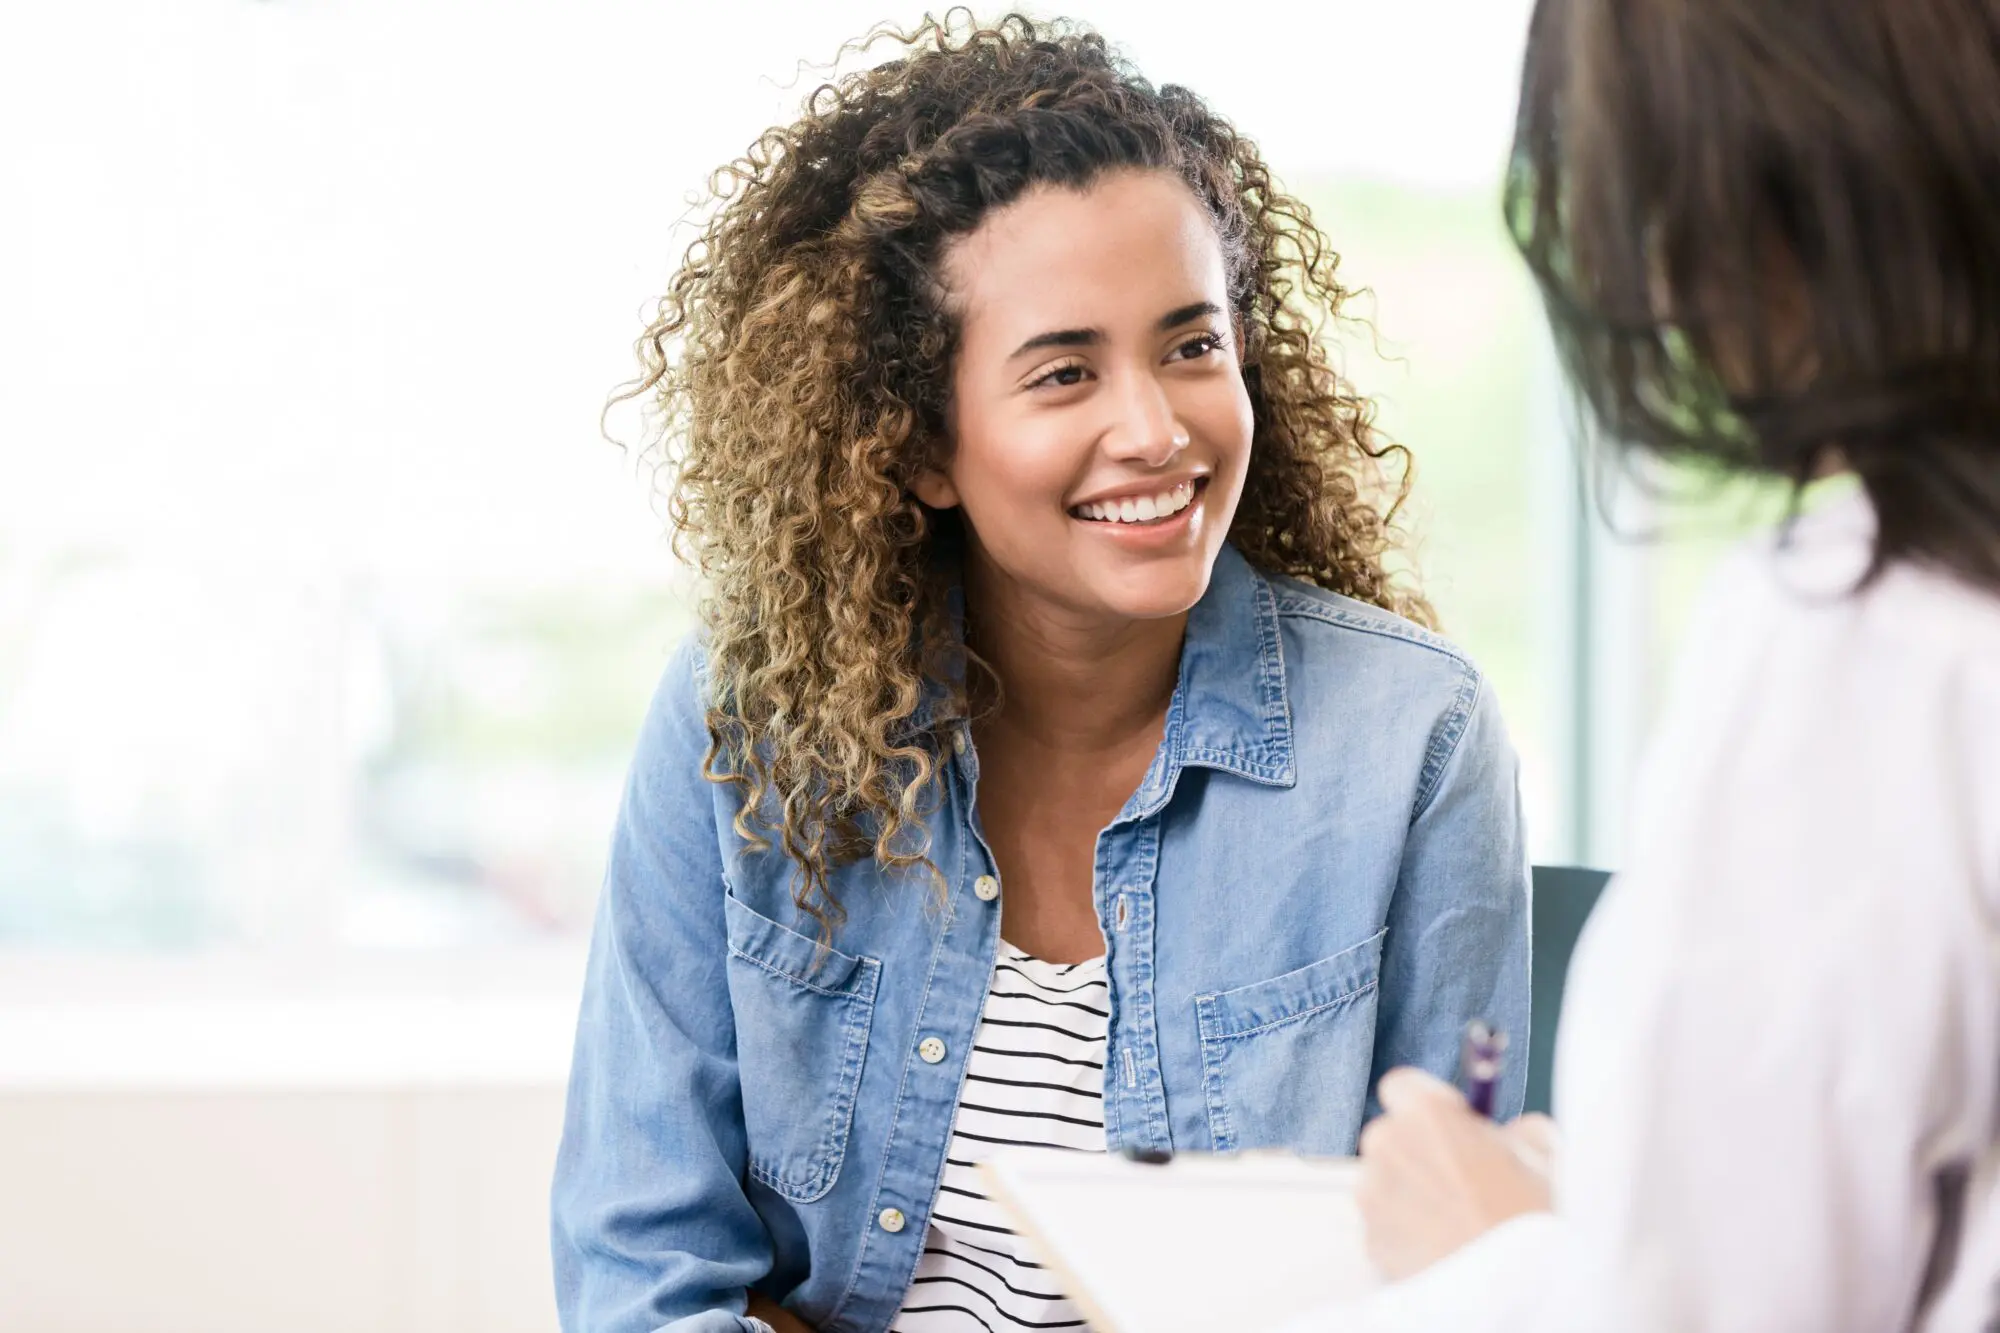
[554,18,1528,1333]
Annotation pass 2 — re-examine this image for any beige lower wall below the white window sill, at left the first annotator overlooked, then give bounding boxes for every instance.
[0,1085,562,1333]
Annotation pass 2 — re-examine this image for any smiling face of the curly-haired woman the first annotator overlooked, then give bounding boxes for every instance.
[916,170,1250,620]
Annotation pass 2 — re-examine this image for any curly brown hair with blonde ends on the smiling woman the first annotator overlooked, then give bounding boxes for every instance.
[614,10,1432,939]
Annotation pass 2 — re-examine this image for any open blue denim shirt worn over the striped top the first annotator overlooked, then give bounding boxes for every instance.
[552,548,1528,1333]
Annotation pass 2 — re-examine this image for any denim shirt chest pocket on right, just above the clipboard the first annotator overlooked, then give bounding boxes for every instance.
[1194,931,1386,1155]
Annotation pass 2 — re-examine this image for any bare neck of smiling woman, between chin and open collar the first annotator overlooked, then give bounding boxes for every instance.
[966,560,1188,753]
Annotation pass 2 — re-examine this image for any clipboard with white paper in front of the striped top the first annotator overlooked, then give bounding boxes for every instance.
[980,1149,1380,1333]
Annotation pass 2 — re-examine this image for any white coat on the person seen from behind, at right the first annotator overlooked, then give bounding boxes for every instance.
[1296,496,2000,1333]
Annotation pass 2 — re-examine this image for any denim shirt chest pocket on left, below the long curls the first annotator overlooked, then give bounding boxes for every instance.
[724,895,882,1203]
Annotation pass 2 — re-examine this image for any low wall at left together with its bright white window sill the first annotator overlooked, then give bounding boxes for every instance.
[0,949,582,1333]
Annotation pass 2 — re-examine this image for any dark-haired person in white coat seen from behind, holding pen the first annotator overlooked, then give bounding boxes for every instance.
[1302,0,2000,1333]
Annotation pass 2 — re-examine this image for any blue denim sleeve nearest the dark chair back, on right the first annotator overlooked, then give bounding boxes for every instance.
[1368,677,1528,1119]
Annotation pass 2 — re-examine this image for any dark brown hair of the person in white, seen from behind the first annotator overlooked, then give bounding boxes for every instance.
[1506,0,2000,592]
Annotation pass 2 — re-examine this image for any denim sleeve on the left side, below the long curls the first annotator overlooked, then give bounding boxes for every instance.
[552,642,772,1333]
